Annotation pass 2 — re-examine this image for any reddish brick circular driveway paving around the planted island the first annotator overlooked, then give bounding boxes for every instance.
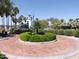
[0,36,79,56]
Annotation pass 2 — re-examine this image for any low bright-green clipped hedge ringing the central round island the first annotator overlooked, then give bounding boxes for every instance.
[20,33,56,42]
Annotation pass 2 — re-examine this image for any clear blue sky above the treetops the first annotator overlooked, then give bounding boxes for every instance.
[13,0,79,19]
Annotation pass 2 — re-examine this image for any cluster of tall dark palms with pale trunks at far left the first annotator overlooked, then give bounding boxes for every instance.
[0,0,19,29]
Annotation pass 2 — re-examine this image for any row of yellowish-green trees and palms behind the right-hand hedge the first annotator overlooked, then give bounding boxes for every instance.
[47,18,79,29]
